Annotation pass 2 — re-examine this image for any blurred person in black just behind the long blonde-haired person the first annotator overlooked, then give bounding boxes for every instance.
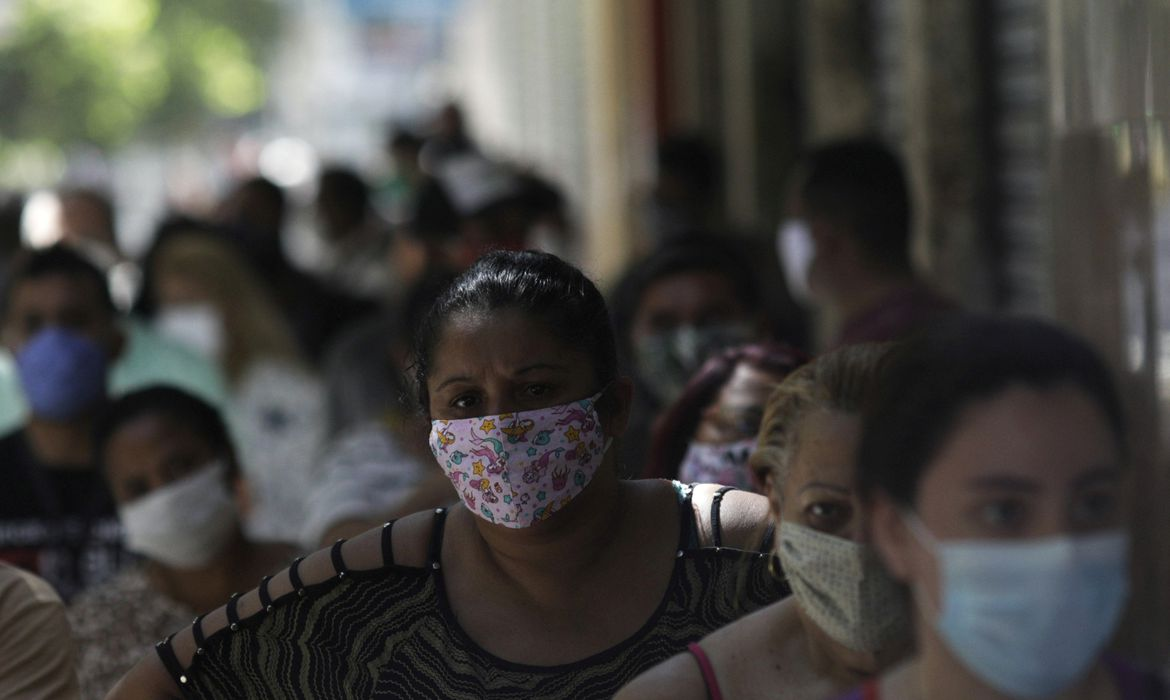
[214,177,377,362]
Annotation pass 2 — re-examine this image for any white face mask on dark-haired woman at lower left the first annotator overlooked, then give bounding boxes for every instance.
[118,461,239,569]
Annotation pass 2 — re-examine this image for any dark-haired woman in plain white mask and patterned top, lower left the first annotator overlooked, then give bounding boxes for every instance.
[69,386,296,699]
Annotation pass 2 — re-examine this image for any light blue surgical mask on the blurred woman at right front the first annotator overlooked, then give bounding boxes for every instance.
[904,513,1129,698]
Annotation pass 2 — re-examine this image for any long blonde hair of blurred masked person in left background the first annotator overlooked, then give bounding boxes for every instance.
[153,233,305,384]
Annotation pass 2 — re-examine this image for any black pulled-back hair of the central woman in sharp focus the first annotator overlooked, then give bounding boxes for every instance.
[414,251,618,414]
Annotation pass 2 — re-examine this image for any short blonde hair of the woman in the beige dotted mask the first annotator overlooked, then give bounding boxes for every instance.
[749,343,893,497]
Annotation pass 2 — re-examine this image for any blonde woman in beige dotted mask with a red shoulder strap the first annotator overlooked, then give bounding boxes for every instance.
[618,345,910,700]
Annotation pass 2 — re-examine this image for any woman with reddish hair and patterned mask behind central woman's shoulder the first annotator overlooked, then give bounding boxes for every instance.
[646,343,806,495]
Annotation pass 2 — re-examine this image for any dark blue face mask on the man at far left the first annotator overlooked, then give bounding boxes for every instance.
[16,327,108,420]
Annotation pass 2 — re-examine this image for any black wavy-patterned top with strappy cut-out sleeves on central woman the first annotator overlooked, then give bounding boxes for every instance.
[158,483,789,700]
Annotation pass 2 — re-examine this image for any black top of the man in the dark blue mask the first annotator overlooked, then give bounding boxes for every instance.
[0,430,129,602]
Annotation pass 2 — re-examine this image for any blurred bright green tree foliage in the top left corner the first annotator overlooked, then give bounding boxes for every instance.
[0,0,280,151]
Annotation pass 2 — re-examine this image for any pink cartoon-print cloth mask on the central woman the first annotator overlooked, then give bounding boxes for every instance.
[431,391,611,528]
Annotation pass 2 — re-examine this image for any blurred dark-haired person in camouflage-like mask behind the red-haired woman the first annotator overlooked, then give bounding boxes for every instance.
[612,238,770,475]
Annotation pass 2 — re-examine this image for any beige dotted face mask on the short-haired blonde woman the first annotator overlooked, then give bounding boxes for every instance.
[777,521,910,652]
